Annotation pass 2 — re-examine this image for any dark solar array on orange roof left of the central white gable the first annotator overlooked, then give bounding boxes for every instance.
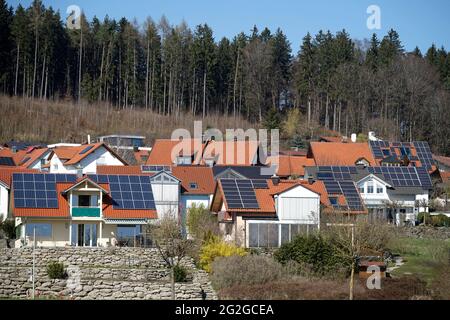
[220,179,268,209]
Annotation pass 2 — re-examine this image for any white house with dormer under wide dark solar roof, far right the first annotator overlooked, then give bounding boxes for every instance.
[305,166,432,224]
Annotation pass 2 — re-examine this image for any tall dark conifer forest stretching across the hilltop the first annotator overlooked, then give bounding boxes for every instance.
[0,0,450,155]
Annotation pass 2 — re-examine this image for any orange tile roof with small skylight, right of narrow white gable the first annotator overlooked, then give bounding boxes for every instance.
[172,166,216,194]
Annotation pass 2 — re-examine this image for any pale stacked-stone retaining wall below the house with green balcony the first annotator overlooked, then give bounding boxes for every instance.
[0,248,217,299]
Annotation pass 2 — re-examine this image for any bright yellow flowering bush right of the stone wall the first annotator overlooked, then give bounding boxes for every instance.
[199,237,247,272]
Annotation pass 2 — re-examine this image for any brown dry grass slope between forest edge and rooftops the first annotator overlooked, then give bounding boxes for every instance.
[0,96,254,143]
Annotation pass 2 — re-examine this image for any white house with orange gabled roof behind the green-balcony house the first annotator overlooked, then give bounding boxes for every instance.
[46,143,127,174]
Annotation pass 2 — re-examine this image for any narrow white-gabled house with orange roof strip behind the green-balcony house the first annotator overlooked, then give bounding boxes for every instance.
[97,165,181,217]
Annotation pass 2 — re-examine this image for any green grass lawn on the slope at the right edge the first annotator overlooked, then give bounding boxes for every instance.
[389,237,450,284]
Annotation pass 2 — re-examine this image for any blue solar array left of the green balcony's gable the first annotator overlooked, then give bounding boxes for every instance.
[12,173,76,208]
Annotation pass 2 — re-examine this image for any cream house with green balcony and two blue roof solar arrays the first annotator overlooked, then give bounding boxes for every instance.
[11,173,158,247]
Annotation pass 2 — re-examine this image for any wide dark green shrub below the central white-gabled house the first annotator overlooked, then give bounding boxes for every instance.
[274,235,351,275]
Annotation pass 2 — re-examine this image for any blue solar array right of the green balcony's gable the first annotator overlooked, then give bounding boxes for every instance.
[88,174,156,210]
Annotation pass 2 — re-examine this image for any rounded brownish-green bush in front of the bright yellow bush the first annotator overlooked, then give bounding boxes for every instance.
[211,255,284,290]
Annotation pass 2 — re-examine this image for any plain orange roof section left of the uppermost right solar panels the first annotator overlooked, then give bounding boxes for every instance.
[309,142,377,166]
